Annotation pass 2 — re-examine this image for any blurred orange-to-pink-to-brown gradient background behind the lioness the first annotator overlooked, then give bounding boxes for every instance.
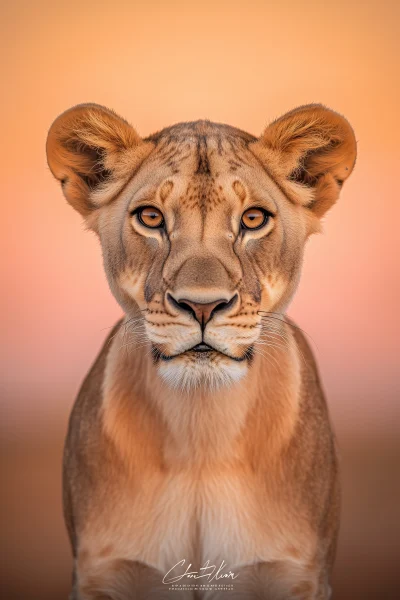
[0,0,400,600]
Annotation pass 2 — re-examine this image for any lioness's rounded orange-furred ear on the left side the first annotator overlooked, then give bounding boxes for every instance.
[46,104,154,217]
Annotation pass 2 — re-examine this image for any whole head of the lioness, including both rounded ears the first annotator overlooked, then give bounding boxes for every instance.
[48,105,355,388]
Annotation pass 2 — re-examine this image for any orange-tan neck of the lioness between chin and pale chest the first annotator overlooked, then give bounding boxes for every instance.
[103,324,300,466]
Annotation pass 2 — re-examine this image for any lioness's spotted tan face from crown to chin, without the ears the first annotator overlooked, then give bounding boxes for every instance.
[98,123,307,386]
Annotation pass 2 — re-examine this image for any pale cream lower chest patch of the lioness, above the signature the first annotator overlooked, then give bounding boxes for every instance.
[82,471,306,573]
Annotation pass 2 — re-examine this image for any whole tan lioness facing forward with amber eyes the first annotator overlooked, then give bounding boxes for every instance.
[47,104,356,600]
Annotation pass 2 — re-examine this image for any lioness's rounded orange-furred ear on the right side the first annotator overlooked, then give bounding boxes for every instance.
[251,104,357,217]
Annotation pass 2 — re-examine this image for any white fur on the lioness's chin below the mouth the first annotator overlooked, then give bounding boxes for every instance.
[158,359,247,391]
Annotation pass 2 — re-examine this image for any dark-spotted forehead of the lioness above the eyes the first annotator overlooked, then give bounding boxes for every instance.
[123,121,279,214]
